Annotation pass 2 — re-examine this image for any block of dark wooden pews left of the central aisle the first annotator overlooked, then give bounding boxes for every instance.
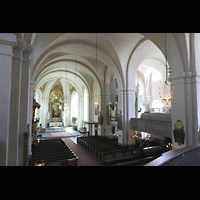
[28,139,78,166]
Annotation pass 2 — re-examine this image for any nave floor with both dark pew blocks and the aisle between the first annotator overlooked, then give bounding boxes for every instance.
[28,128,169,166]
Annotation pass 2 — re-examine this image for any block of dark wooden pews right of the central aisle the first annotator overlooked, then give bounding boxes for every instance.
[77,136,162,166]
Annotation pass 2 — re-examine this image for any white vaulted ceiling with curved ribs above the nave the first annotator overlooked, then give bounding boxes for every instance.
[13,33,187,94]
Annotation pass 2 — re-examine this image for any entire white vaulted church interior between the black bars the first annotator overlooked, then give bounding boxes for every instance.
[0,33,200,166]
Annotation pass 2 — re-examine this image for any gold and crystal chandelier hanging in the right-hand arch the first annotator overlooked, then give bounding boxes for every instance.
[159,33,174,112]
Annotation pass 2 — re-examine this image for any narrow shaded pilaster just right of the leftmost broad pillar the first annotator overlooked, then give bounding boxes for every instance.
[8,39,26,166]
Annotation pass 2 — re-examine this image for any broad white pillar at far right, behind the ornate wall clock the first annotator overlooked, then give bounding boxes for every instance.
[171,33,200,149]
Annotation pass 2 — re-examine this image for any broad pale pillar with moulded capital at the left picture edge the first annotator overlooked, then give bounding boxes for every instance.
[0,33,16,166]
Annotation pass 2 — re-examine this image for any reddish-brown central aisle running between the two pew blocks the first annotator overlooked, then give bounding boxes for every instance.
[62,138,103,166]
